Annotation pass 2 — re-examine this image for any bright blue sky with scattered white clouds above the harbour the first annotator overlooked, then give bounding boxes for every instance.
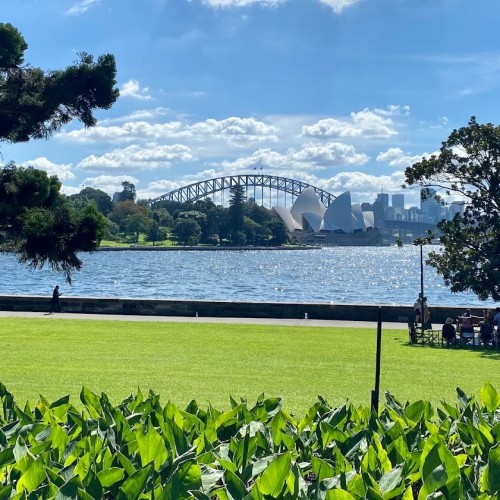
[0,0,500,207]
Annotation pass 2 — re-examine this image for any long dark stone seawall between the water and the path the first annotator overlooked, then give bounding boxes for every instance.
[0,295,483,325]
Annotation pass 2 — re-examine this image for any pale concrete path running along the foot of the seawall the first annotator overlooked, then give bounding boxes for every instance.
[0,311,408,330]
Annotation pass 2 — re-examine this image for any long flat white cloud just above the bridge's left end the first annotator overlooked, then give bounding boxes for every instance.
[77,144,194,171]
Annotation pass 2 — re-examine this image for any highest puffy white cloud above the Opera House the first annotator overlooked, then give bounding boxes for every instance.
[302,108,398,138]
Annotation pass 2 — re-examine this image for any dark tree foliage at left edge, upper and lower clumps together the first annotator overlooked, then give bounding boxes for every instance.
[0,23,119,282]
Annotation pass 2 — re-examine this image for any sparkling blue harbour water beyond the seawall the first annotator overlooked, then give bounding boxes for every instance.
[0,245,495,307]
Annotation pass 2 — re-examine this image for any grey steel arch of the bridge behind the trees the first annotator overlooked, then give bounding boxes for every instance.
[149,174,336,208]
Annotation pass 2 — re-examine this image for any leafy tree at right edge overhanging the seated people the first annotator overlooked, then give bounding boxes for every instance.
[405,117,500,301]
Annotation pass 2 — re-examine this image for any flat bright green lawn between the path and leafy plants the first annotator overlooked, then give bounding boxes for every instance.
[0,318,500,416]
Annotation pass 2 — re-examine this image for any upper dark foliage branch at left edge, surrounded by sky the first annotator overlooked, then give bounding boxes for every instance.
[0,23,119,142]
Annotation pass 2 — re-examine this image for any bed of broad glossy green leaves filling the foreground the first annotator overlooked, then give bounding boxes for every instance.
[0,383,500,500]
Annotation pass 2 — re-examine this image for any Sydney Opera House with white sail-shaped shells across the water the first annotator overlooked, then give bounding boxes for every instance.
[273,187,382,246]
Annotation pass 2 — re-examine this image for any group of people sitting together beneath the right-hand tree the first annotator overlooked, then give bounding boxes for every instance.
[441,307,500,345]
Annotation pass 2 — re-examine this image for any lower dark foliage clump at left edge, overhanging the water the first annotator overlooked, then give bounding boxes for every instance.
[0,163,106,282]
